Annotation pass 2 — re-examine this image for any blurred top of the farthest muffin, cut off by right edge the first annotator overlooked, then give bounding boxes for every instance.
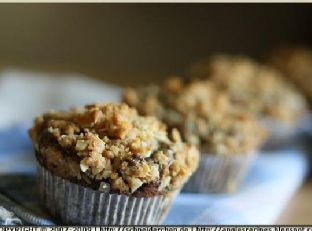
[270,47,312,103]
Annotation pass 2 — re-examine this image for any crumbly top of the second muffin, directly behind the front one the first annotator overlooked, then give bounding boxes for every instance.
[123,77,264,155]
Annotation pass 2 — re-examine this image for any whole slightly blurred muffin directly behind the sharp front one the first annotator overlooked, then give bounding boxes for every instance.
[123,77,265,193]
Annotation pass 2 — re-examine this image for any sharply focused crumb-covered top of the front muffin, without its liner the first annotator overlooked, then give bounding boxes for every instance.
[29,103,199,196]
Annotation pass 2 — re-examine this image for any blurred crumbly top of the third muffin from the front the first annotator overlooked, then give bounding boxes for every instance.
[191,55,306,124]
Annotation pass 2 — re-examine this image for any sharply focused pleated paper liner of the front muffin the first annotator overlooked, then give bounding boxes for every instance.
[37,164,178,225]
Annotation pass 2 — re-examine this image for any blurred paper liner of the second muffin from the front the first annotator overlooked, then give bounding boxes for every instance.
[182,153,256,193]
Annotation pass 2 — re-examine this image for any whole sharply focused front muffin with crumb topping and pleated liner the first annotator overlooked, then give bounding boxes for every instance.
[29,103,199,225]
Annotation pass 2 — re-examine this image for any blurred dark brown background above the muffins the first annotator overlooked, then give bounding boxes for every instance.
[0,4,312,85]
